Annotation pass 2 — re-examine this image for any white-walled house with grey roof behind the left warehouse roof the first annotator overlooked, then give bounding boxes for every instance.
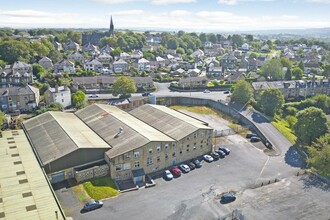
[44,85,71,108]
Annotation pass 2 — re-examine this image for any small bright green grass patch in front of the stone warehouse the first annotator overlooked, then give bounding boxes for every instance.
[81,177,119,200]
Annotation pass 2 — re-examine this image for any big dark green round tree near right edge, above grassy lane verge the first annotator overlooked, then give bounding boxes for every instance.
[293,107,329,145]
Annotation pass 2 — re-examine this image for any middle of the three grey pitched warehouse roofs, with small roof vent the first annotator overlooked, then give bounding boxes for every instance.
[75,104,173,158]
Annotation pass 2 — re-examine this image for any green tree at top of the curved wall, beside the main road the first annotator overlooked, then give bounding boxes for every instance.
[231,80,253,104]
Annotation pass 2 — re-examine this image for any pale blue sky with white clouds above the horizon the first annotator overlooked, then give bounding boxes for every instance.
[0,0,330,32]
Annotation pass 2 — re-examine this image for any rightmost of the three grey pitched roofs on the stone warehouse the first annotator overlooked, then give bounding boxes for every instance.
[129,104,211,140]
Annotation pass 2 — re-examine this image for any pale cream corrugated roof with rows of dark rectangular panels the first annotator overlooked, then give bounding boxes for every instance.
[0,130,63,220]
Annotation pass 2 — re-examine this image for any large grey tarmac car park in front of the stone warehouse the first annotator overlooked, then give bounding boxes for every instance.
[58,111,330,220]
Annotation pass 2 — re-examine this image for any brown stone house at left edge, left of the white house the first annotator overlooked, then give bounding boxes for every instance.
[0,85,40,113]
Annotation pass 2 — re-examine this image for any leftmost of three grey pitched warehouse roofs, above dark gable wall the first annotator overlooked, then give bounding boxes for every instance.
[23,112,111,165]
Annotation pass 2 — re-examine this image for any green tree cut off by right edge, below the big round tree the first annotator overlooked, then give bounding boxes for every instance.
[307,133,330,178]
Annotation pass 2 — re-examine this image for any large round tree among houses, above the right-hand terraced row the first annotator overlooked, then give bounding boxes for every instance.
[261,59,284,81]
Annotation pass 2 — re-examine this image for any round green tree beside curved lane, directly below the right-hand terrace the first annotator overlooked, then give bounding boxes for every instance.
[258,88,284,116]
